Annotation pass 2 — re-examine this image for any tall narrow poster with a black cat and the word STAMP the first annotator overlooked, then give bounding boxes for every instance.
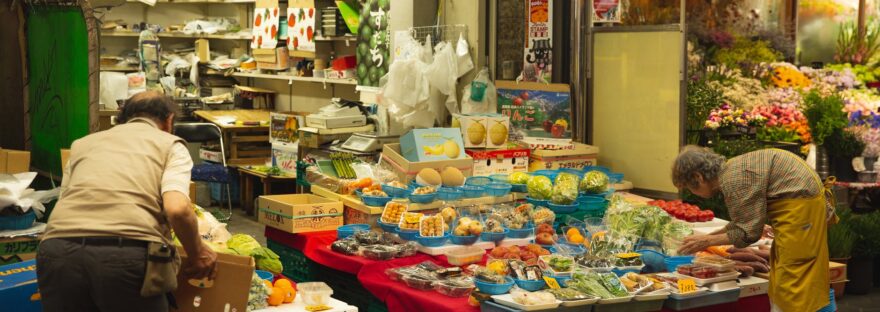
[517,0,553,83]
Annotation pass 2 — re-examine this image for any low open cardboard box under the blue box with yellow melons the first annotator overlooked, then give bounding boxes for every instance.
[382,144,474,183]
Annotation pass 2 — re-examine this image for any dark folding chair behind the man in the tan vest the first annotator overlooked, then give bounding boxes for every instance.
[174,123,232,222]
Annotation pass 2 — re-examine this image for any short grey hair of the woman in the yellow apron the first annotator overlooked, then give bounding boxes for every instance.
[672,145,726,188]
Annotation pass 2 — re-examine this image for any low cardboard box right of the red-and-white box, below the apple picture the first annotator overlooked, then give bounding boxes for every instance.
[529,142,599,171]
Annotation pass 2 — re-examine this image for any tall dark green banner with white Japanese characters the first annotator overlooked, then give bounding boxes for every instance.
[357,0,391,87]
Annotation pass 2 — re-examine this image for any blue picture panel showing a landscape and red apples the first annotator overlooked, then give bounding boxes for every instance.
[495,80,571,140]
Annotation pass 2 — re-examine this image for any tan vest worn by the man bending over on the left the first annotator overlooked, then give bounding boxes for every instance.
[43,121,183,243]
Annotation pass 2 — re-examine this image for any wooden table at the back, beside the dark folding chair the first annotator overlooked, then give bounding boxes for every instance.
[193,109,272,165]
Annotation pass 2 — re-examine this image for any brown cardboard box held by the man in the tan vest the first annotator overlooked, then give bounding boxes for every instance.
[170,248,254,312]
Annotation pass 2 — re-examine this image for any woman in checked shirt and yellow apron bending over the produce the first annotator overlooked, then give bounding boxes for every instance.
[672,146,835,312]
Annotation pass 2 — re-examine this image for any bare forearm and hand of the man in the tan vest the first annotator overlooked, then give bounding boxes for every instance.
[162,191,217,279]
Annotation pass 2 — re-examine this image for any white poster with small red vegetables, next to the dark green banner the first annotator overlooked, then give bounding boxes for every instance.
[287,0,316,52]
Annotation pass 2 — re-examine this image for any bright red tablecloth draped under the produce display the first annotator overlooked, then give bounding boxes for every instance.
[266,227,770,312]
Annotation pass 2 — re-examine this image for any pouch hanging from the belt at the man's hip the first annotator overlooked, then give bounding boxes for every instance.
[141,242,180,297]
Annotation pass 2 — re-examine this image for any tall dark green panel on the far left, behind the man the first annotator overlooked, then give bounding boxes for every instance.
[27,6,89,176]
